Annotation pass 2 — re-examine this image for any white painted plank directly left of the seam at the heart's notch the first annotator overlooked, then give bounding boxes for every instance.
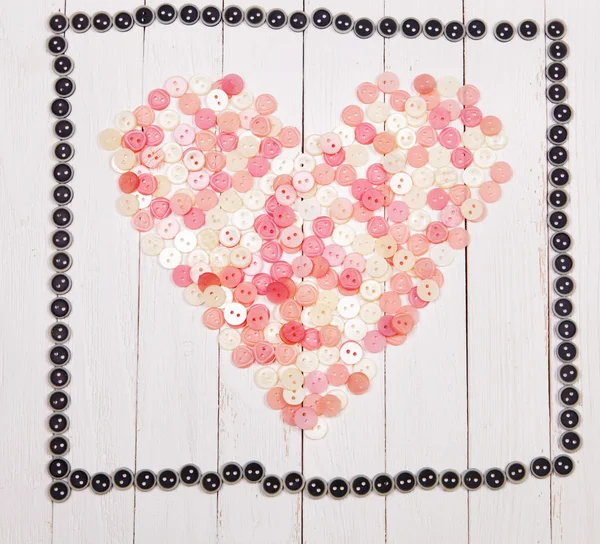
[218,0,303,544]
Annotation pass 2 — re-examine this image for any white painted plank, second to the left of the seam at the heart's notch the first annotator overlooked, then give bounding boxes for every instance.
[135,0,221,542]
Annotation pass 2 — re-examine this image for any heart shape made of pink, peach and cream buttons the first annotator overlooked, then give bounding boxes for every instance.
[100,72,512,438]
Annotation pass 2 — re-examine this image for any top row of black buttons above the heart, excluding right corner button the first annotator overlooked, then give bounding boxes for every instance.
[50,9,539,42]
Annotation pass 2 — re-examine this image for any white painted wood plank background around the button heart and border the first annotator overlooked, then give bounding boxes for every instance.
[0,0,600,544]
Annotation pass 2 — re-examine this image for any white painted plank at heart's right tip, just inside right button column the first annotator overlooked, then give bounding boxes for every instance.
[465,0,550,544]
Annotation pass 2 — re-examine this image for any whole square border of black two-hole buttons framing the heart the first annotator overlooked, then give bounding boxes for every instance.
[46,11,581,503]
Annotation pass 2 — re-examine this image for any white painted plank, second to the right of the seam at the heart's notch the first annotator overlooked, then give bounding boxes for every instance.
[386,0,468,543]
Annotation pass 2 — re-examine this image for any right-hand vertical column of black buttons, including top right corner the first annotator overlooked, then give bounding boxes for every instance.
[546,20,581,452]
